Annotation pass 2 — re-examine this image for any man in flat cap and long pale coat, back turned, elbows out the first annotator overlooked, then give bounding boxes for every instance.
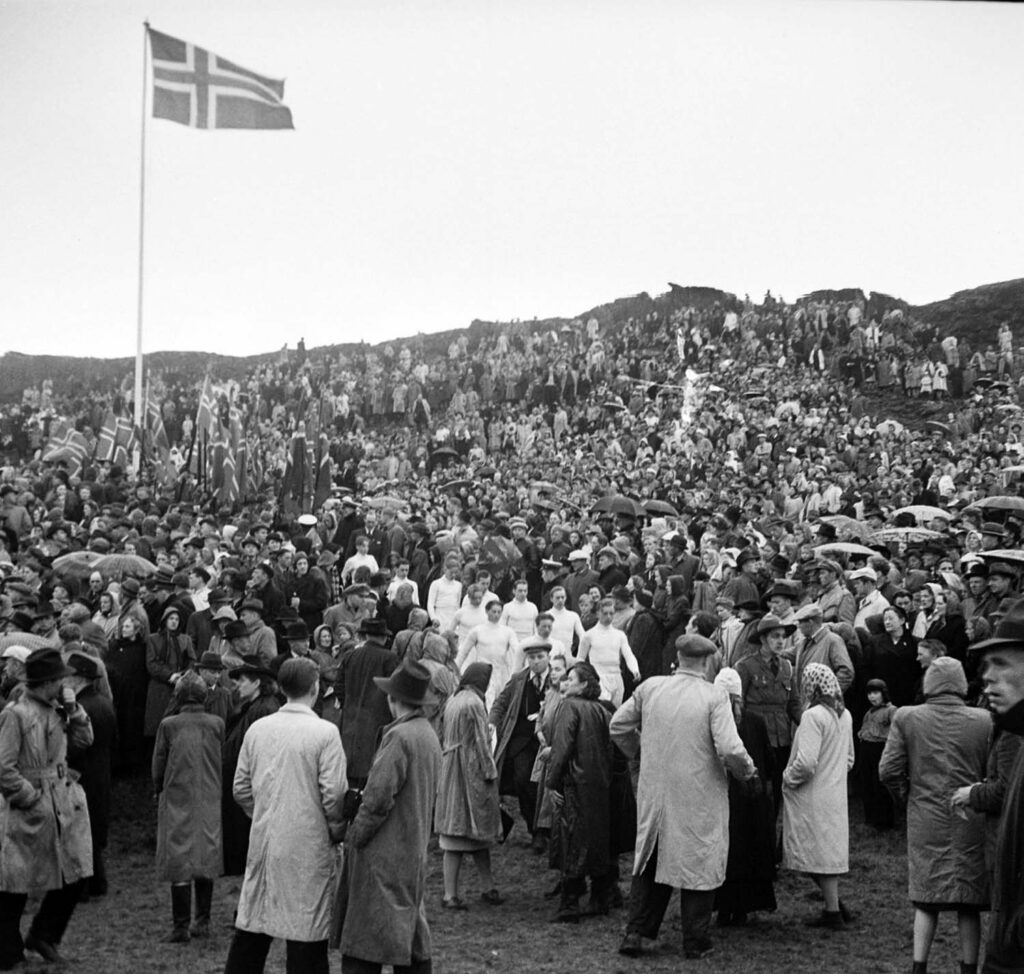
[610,635,757,959]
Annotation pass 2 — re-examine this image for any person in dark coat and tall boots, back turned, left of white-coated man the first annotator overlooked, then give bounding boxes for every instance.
[153,673,224,943]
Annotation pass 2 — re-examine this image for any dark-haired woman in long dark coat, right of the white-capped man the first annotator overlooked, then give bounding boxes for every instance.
[546,662,615,923]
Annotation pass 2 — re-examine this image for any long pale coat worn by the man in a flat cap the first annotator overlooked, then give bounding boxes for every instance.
[610,672,755,890]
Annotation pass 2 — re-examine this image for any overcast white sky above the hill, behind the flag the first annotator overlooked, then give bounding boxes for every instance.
[0,0,1024,356]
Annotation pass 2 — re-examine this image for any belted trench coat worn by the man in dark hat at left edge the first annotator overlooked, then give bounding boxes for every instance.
[0,694,92,893]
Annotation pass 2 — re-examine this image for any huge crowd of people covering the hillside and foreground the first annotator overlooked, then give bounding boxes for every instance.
[0,295,1024,974]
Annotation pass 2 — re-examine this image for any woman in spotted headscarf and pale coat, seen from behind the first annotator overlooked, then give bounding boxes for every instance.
[782,663,854,930]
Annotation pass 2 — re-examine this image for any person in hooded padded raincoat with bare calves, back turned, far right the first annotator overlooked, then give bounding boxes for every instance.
[879,657,992,974]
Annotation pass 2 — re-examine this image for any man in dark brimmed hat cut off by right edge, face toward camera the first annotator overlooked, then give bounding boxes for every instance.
[952,601,1024,974]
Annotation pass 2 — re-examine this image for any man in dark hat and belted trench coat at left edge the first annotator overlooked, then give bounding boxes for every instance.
[0,648,92,971]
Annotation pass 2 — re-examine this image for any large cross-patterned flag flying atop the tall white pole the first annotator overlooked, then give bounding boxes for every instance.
[148,30,295,128]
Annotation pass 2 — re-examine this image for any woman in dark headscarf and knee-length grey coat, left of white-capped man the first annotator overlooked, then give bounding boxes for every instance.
[434,663,503,909]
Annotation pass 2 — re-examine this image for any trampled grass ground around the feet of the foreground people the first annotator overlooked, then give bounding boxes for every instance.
[27,782,974,974]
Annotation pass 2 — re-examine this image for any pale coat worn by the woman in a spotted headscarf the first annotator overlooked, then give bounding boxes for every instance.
[782,704,853,876]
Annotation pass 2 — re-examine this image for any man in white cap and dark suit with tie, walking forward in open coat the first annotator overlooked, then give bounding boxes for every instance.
[490,639,551,852]
